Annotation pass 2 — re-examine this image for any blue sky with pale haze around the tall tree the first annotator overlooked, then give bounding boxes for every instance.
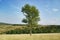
[0,0,60,25]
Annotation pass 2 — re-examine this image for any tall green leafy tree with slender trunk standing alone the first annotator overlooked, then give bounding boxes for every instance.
[21,4,40,35]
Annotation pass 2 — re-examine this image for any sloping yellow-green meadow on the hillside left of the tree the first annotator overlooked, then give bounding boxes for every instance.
[0,24,23,34]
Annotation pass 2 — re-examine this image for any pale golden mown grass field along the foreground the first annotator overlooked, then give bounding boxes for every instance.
[0,33,60,40]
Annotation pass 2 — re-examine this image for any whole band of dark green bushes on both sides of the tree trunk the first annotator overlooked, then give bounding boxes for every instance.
[5,25,60,34]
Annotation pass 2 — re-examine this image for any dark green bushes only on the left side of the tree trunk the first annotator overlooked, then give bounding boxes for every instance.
[5,27,29,34]
